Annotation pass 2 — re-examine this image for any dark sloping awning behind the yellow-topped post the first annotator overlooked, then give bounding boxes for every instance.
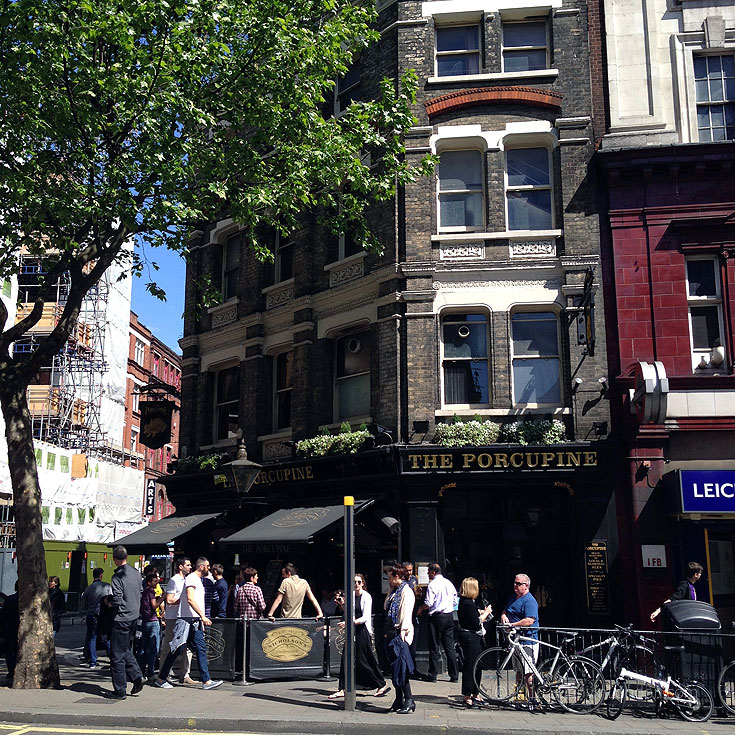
[220,500,373,544]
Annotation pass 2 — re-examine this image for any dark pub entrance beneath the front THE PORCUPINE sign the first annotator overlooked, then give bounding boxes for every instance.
[438,483,577,626]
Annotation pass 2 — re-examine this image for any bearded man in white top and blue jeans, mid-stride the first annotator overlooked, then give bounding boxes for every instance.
[153,556,222,690]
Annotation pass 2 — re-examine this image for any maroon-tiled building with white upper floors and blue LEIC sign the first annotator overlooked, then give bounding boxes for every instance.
[593,0,735,624]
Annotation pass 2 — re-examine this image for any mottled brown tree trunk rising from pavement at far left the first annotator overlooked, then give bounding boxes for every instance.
[0,380,60,689]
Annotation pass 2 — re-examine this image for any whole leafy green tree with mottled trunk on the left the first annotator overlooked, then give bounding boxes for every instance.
[0,0,433,688]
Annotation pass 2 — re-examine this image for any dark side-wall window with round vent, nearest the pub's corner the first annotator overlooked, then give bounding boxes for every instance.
[334,330,370,421]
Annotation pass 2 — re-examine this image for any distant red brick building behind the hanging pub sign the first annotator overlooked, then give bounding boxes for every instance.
[124,311,181,521]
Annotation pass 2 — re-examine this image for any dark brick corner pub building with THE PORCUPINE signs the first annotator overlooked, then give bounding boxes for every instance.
[175,0,617,624]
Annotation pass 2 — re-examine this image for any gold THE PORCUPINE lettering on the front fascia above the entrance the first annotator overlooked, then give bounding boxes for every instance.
[407,449,597,472]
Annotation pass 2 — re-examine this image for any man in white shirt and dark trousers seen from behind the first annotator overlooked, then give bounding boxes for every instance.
[419,562,459,681]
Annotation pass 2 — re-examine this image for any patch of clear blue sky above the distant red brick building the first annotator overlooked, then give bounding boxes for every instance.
[131,248,186,355]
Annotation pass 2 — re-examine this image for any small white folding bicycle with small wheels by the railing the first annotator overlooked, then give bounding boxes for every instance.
[607,668,714,722]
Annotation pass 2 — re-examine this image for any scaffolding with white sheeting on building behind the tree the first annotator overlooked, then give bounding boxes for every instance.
[13,256,110,455]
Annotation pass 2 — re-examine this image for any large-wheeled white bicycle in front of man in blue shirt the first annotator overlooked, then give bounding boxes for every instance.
[475,626,605,714]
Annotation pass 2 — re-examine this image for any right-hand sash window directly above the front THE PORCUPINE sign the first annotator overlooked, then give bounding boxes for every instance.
[511,311,561,406]
